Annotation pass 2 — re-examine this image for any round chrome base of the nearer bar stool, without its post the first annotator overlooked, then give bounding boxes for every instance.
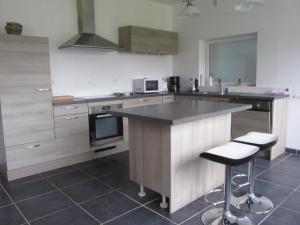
[201,208,253,225]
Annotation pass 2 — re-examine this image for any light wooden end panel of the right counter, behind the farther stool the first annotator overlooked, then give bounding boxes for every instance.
[270,98,289,160]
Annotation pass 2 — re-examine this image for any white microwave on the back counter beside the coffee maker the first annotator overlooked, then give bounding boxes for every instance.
[133,79,160,93]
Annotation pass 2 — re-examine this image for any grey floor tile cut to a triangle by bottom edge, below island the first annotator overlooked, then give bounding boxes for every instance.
[107,207,174,225]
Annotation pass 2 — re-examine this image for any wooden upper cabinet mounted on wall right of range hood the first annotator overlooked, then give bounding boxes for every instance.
[119,26,178,55]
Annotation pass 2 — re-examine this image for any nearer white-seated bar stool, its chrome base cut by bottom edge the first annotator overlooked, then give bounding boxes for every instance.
[200,142,259,225]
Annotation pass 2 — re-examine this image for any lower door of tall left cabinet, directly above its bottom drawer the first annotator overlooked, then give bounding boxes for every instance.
[1,92,54,146]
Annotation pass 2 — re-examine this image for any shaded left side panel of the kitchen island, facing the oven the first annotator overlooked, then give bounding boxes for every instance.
[129,118,171,197]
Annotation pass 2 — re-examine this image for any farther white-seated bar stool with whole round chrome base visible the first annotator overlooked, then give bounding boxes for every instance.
[231,132,278,214]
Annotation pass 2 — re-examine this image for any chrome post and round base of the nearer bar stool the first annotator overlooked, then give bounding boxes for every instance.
[201,166,253,225]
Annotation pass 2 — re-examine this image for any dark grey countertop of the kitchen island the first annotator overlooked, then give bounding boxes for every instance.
[110,101,252,125]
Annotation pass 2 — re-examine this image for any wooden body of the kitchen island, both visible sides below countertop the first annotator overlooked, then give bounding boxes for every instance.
[129,114,231,213]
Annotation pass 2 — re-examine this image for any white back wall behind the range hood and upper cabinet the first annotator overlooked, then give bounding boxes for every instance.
[0,0,172,96]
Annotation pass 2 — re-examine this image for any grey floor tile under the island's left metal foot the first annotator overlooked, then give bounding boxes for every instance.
[119,183,161,204]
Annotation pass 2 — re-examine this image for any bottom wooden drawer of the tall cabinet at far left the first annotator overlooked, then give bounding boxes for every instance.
[6,141,57,170]
